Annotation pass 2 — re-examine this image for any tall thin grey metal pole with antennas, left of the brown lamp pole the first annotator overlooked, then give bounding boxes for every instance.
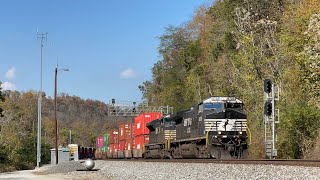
[37,32,48,167]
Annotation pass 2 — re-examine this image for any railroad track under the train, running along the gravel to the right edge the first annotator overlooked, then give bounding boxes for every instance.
[100,159,320,167]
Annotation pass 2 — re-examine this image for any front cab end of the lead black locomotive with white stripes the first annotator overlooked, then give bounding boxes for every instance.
[198,97,247,158]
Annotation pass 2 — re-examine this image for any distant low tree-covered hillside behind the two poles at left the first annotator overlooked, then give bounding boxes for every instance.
[0,91,132,168]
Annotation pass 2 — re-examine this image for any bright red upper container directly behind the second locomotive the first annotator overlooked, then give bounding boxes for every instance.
[134,112,161,136]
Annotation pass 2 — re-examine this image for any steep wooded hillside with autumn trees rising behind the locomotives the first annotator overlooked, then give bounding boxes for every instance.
[140,0,320,159]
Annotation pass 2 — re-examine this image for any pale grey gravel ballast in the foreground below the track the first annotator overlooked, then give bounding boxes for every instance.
[34,160,320,180]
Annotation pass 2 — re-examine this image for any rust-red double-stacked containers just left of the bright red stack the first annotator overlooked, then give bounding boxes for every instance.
[118,123,133,158]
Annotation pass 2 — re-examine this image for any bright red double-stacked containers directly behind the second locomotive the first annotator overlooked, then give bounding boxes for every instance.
[133,112,161,158]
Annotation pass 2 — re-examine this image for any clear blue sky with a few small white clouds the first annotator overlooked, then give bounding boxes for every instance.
[0,0,212,103]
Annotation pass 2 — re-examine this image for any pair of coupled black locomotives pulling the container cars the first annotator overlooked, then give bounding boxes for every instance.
[144,97,248,159]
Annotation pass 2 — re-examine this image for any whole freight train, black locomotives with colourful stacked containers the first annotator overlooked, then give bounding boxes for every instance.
[97,97,248,159]
